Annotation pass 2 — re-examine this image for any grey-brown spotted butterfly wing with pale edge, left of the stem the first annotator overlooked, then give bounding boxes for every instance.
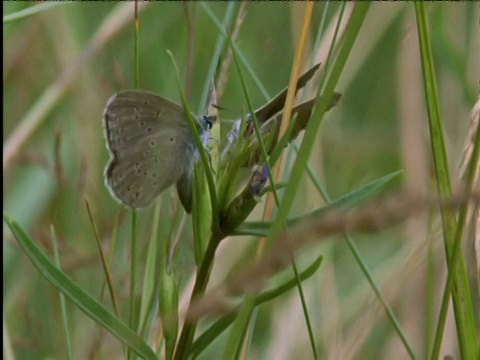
[103,90,194,208]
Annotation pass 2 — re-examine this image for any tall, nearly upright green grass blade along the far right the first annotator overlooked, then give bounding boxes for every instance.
[415,2,479,359]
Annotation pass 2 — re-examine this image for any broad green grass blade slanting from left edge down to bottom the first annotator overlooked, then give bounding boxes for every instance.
[3,214,156,360]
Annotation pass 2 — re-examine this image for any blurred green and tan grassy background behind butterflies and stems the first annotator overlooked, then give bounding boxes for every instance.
[3,2,480,359]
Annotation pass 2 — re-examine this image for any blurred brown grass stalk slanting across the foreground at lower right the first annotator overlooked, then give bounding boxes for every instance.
[187,192,480,320]
